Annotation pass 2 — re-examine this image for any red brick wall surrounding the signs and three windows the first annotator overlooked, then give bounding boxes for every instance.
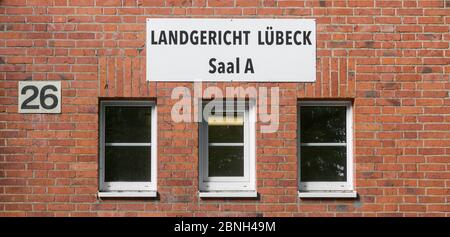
[0,0,450,216]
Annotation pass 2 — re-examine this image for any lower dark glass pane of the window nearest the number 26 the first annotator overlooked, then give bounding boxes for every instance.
[105,146,151,182]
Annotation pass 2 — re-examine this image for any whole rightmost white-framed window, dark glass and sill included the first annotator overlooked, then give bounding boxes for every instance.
[298,101,356,197]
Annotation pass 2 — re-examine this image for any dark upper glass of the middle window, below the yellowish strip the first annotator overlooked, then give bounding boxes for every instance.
[208,125,244,143]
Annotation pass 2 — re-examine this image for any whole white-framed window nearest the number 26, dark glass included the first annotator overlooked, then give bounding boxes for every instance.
[99,101,157,196]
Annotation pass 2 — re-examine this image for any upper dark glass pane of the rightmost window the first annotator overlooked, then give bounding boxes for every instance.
[300,106,347,143]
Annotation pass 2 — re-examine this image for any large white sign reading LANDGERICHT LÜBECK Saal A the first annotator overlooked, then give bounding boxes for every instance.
[146,18,316,82]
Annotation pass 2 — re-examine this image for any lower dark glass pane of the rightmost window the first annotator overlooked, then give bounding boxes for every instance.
[300,146,347,182]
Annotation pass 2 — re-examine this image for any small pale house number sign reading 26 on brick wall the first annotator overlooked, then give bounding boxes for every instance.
[18,81,61,114]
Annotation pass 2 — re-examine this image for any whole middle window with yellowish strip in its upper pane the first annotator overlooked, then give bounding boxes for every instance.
[199,101,256,197]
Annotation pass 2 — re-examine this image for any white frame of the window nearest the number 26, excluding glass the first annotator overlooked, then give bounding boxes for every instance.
[99,101,158,194]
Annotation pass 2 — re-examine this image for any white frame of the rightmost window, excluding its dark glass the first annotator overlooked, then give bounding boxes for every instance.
[297,101,354,192]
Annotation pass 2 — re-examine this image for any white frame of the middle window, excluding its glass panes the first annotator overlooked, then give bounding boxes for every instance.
[199,100,256,193]
